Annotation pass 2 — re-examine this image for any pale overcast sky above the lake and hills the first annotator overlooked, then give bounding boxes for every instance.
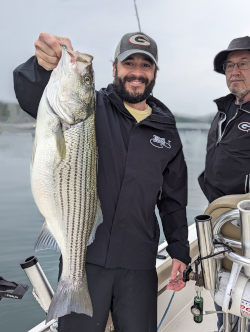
[0,0,250,116]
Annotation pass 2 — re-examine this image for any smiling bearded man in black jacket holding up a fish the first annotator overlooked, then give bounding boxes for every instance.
[14,32,190,332]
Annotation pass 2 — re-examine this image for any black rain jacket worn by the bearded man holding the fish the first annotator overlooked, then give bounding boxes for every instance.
[14,57,190,270]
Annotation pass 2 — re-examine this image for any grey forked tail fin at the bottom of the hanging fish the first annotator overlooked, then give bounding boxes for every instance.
[46,272,93,323]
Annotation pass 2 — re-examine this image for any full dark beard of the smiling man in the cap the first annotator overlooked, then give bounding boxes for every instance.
[113,70,155,104]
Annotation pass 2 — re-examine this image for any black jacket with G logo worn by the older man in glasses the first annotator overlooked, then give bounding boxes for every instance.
[198,94,250,202]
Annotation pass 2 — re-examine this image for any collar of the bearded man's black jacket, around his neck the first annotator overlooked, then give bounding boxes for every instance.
[102,84,175,129]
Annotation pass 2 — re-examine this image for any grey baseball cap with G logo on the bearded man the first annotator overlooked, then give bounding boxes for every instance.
[115,32,158,65]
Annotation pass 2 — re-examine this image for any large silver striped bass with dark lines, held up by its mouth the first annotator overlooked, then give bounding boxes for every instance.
[31,45,102,322]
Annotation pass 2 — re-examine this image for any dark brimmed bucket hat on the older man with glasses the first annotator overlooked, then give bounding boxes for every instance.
[214,36,250,74]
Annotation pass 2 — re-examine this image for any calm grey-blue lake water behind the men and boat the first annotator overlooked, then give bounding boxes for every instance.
[0,126,207,332]
